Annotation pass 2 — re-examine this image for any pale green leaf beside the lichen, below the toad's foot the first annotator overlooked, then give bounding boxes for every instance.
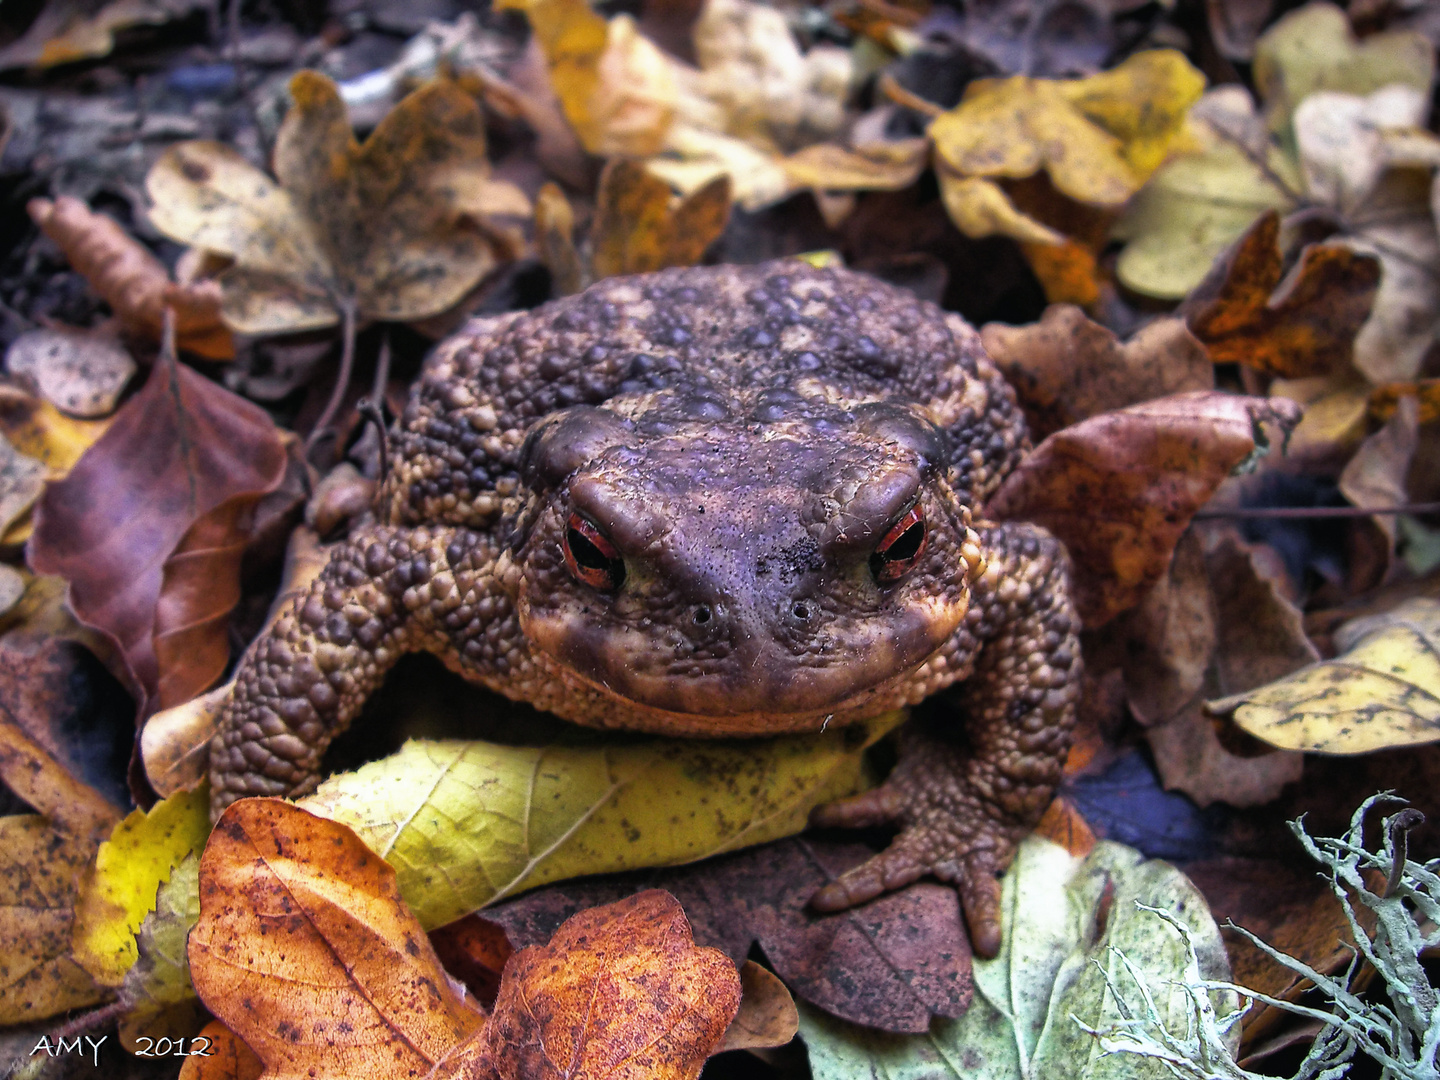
[801,837,1234,1080]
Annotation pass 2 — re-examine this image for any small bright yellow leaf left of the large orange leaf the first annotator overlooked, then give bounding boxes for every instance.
[75,788,210,986]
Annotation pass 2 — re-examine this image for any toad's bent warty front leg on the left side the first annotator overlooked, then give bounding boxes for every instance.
[210,526,508,816]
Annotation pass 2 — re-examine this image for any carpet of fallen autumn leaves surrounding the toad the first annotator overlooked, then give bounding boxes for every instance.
[0,0,1440,1077]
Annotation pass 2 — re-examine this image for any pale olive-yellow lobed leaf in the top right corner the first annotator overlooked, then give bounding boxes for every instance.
[1254,3,1436,134]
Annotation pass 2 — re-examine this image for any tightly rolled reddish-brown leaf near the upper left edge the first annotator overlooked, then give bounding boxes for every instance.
[26,194,235,360]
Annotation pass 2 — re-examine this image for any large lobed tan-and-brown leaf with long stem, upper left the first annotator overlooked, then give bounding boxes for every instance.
[145,71,514,334]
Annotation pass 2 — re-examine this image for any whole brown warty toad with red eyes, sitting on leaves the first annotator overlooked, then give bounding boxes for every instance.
[210,262,1080,955]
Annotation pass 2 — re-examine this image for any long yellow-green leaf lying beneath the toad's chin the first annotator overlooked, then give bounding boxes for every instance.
[300,713,901,927]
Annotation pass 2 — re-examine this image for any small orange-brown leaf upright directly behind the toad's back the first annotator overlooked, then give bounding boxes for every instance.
[590,158,730,278]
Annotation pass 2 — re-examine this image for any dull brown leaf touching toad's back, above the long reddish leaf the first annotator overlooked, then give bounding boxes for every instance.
[981,304,1215,441]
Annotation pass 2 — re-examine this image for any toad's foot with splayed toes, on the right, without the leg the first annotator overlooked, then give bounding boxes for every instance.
[811,729,1034,956]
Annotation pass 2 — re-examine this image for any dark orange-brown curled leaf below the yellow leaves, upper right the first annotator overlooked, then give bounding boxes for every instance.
[1182,210,1380,379]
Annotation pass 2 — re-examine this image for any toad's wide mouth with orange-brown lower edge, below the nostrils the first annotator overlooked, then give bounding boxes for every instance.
[523,598,968,734]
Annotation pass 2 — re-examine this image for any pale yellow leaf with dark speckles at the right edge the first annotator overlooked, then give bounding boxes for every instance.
[1207,598,1440,755]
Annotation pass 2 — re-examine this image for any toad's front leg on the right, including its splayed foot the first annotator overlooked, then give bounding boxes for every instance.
[811,523,1080,956]
